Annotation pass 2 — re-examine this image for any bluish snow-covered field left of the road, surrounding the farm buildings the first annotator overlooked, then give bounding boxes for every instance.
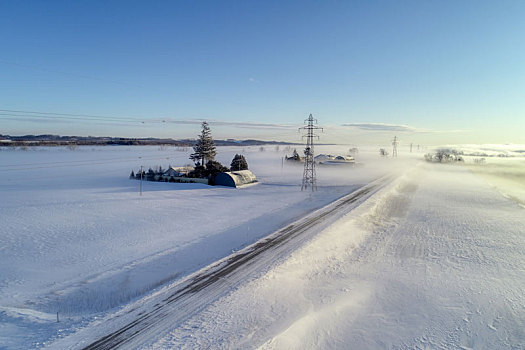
[0,146,392,348]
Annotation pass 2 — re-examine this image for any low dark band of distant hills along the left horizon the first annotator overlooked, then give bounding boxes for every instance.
[0,134,297,146]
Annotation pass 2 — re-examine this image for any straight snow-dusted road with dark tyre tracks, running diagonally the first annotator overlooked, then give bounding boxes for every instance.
[51,178,391,349]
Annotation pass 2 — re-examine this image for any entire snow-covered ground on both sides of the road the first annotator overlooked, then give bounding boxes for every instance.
[0,146,525,349]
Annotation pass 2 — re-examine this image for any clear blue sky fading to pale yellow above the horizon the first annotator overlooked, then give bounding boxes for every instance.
[0,1,525,144]
